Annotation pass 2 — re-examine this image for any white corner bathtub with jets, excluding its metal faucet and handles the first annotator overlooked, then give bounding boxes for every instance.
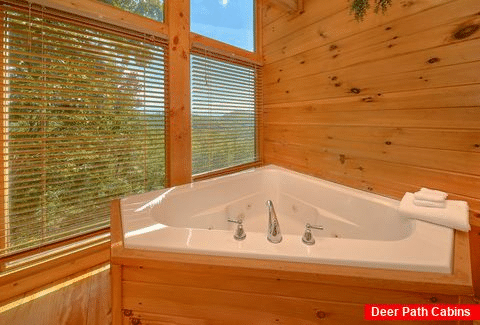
[121,166,454,273]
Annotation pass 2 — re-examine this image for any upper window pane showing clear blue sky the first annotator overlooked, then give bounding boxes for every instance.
[190,0,255,52]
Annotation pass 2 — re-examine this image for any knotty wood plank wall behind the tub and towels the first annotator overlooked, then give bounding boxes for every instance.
[263,0,480,288]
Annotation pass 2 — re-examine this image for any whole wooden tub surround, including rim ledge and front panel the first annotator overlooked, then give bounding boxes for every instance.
[111,200,473,325]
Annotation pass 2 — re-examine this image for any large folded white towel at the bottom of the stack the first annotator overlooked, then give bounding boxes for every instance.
[398,192,470,231]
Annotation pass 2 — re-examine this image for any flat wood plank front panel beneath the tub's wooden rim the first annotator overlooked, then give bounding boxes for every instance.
[118,263,470,325]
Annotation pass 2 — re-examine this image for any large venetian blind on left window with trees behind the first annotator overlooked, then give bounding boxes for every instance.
[0,1,168,256]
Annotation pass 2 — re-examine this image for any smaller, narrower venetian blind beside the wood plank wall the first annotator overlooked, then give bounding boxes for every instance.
[190,48,262,175]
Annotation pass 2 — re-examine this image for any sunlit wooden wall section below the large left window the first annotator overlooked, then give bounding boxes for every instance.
[0,270,111,325]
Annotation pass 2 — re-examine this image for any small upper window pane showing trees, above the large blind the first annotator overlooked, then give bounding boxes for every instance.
[99,0,165,22]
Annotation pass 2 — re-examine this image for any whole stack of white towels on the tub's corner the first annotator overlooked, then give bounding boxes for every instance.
[398,188,470,231]
